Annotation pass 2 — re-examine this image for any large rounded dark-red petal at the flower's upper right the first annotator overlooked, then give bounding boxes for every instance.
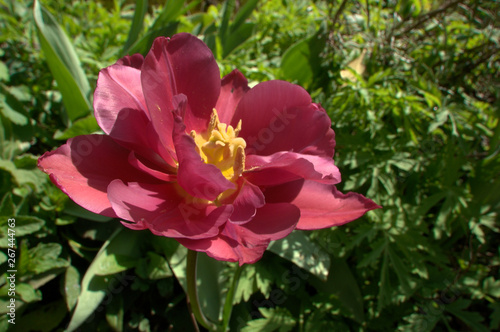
[231,81,334,158]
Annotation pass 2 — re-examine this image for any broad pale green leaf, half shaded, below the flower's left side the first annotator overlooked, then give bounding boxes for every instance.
[67,227,144,331]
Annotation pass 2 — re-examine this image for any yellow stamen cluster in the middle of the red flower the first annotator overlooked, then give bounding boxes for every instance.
[191,108,247,181]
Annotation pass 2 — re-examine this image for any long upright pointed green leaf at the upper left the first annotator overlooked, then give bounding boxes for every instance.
[33,1,91,126]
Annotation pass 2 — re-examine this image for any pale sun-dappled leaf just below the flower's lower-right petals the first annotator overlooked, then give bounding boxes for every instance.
[268,231,330,280]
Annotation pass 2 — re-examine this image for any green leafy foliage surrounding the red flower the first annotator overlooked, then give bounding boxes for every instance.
[0,0,500,332]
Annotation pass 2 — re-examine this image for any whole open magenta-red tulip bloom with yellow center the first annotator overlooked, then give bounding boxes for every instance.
[39,33,379,265]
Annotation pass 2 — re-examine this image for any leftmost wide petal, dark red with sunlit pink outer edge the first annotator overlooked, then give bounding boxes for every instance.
[38,135,155,217]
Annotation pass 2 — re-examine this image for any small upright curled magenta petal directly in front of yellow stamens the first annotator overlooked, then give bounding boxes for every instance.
[173,111,235,201]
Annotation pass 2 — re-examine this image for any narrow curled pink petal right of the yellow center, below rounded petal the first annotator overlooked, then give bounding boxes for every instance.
[245,152,340,186]
